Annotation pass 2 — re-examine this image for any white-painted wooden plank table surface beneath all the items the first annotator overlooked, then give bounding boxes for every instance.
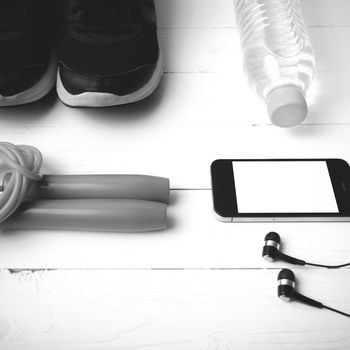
[0,0,350,350]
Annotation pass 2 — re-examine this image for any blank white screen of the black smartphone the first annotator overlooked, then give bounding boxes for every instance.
[233,161,339,213]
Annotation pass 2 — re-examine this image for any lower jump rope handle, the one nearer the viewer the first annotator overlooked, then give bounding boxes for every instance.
[0,199,167,232]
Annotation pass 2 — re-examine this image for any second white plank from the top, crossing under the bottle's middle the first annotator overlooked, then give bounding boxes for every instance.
[159,27,350,74]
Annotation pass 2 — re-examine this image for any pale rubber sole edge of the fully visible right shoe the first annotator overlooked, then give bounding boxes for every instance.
[56,53,163,107]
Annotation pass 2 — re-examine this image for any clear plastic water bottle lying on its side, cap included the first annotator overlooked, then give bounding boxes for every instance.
[234,0,315,127]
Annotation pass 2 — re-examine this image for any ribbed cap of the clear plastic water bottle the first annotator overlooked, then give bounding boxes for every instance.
[267,86,308,128]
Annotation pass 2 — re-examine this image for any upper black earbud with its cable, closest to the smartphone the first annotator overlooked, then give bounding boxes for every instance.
[262,232,350,269]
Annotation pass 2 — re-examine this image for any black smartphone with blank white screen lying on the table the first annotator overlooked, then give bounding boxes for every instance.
[211,159,350,222]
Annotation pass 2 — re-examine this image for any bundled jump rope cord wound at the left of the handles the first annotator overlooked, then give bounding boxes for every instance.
[0,142,42,223]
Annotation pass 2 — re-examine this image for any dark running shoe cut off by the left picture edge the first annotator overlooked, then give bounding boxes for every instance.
[0,0,57,106]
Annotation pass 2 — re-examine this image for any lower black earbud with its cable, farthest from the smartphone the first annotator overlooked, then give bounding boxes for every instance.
[277,269,350,317]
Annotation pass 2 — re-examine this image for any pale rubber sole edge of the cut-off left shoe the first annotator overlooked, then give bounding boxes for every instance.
[0,55,57,107]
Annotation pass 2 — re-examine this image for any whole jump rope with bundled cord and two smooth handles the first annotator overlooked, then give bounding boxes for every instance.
[0,142,169,232]
